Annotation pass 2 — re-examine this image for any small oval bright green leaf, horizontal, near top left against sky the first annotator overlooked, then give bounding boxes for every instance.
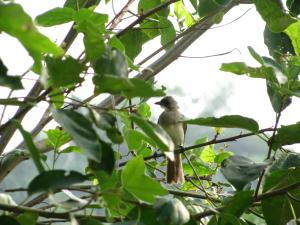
[35,7,76,27]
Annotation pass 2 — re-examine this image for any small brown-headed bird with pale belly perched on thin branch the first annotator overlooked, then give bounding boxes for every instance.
[155,96,187,183]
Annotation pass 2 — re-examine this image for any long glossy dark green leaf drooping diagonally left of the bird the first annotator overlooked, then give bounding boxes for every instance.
[53,109,104,163]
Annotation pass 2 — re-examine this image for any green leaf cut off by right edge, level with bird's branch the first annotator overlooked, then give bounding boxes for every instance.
[272,122,300,149]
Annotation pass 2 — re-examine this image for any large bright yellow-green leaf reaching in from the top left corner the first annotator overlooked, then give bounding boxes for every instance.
[0,3,64,73]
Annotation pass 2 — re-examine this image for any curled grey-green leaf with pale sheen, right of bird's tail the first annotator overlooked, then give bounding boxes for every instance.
[221,155,274,190]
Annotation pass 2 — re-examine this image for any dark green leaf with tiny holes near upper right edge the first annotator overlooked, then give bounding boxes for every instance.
[264,26,295,58]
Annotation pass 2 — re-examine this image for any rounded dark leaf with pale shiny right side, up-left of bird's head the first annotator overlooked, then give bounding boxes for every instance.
[93,48,128,77]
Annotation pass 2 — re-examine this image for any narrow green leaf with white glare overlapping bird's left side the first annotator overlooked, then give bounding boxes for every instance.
[130,115,175,151]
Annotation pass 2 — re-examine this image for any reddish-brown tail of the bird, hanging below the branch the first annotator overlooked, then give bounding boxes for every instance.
[167,154,184,183]
